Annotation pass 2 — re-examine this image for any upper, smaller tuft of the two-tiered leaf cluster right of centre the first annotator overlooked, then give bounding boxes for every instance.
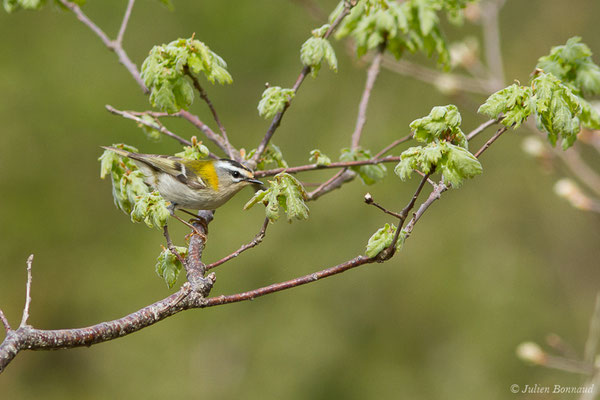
[410,104,468,148]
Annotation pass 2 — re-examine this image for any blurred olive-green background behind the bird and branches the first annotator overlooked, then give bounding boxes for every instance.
[0,0,600,399]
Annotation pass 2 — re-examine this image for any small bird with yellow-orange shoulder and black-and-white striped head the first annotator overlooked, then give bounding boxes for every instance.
[102,146,263,225]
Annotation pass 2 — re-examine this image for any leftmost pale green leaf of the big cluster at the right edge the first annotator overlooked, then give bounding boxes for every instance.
[477,84,532,129]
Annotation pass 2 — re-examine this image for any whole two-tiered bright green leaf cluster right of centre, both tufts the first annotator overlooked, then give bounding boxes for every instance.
[394,105,483,187]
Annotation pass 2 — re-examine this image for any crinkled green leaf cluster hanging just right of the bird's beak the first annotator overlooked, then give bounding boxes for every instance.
[244,172,309,223]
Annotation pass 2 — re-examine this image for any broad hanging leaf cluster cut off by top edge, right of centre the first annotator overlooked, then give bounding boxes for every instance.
[330,0,469,65]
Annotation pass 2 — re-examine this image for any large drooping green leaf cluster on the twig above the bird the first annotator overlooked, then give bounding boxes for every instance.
[141,37,233,114]
